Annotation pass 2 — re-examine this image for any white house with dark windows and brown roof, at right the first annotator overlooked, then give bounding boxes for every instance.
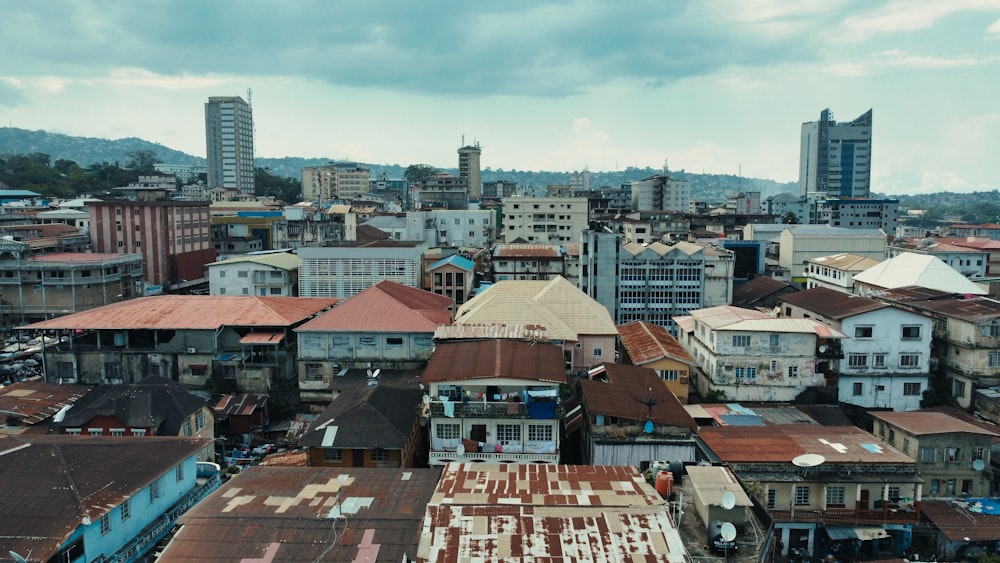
[781,288,932,411]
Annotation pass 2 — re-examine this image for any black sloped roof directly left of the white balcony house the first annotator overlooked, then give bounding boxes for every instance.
[299,385,423,450]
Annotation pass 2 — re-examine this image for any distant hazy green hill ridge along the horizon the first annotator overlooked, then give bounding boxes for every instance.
[0,127,798,202]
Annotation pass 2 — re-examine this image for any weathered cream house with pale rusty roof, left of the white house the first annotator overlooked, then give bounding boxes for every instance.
[674,305,844,401]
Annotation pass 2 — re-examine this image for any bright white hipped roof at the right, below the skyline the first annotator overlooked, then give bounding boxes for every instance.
[854,252,988,295]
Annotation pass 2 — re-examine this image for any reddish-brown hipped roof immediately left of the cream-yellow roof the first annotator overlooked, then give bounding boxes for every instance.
[297,280,454,333]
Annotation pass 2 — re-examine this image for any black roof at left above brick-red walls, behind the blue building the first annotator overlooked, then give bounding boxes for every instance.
[56,376,208,436]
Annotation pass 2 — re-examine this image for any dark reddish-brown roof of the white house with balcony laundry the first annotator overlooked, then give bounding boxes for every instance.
[423,340,566,383]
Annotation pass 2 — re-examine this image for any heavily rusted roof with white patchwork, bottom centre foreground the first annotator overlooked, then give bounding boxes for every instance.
[418,463,689,563]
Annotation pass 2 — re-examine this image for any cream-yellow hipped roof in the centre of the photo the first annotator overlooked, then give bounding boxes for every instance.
[455,276,618,341]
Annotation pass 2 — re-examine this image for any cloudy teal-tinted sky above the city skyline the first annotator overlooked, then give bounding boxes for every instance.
[0,0,1000,194]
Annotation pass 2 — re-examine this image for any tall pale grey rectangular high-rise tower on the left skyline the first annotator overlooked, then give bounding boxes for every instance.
[205,96,254,194]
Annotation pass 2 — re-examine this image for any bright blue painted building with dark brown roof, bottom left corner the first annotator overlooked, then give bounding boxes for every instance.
[0,435,219,563]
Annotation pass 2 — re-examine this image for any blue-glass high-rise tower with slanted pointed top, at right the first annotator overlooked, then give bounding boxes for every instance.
[799,109,872,201]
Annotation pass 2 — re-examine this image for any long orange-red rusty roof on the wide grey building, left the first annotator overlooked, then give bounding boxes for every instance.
[20,295,338,330]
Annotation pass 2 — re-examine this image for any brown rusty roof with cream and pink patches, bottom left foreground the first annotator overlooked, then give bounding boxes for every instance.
[158,466,441,563]
